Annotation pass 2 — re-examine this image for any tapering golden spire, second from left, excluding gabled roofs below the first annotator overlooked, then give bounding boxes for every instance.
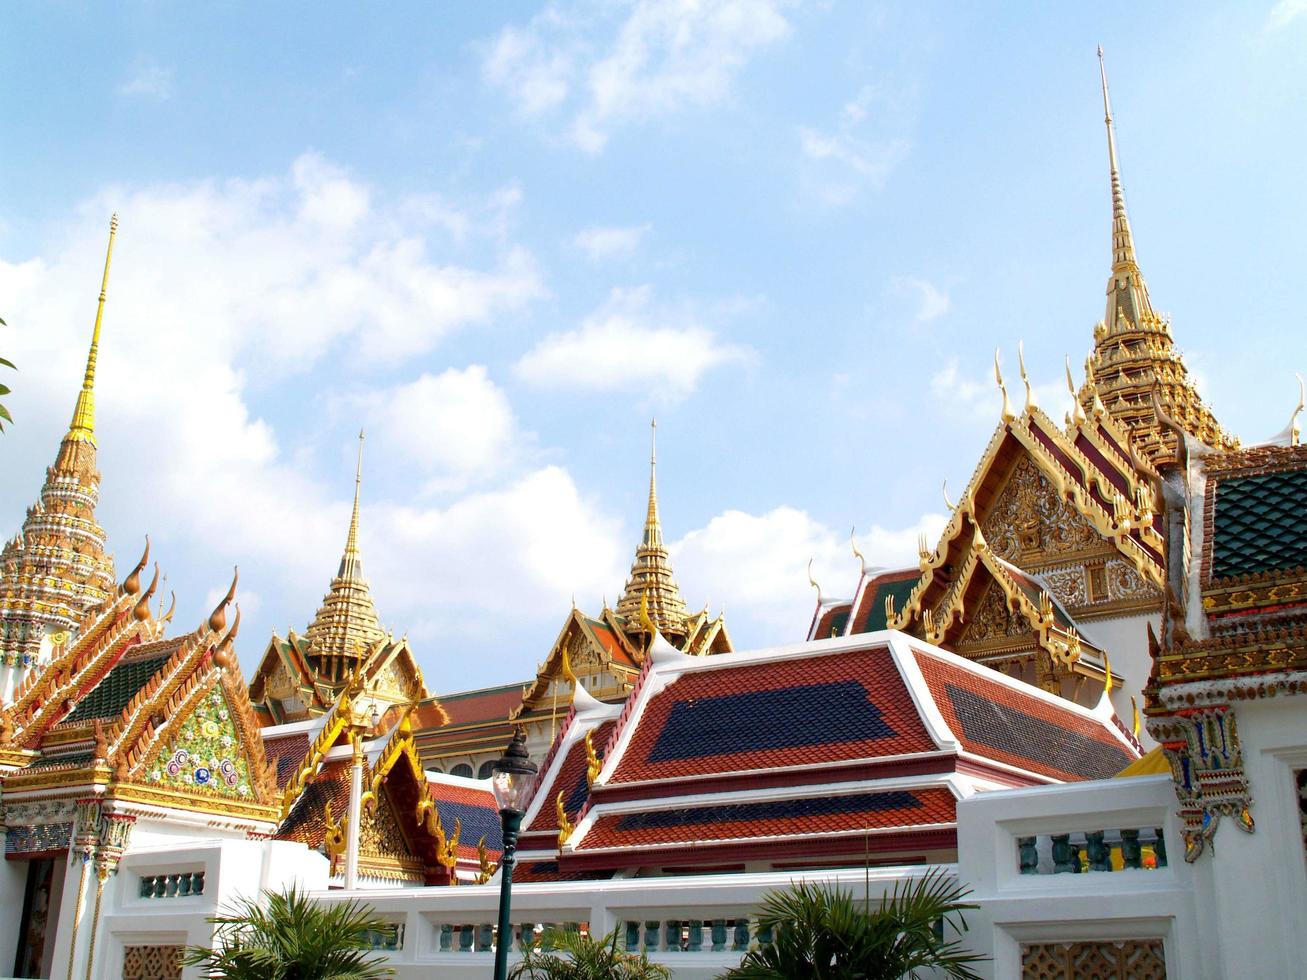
[305,431,386,685]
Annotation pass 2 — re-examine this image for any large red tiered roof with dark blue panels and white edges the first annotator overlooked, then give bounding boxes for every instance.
[501,632,1138,879]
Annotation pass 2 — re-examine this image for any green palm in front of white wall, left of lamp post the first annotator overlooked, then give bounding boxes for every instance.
[184,886,395,980]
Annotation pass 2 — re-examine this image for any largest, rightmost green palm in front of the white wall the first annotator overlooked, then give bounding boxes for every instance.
[724,869,984,980]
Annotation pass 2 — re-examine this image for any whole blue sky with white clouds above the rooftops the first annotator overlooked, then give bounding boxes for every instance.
[0,0,1307,691]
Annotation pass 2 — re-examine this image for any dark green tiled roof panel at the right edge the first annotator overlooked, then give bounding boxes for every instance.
[1212,469,1307,579]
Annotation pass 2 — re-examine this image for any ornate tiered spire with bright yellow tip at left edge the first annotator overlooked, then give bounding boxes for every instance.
[0,214,118,674]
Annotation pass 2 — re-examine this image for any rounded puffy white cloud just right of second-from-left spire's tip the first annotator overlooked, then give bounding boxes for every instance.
[359,365,523,490]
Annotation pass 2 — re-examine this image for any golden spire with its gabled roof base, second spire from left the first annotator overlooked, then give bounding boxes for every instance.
[250,433,426,725]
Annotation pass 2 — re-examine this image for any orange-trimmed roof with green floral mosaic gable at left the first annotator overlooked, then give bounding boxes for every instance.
[0,557,276,831]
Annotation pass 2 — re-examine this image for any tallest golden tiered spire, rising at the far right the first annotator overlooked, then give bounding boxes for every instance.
[1078,48,1238,466]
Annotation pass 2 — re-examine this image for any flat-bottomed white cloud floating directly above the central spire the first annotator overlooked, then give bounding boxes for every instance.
[516,286,753,400]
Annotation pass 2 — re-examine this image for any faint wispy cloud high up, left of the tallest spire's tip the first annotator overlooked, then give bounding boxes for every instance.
[799,85,911,206]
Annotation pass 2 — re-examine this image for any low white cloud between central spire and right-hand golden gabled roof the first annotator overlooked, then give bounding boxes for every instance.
[672,507,945,647]
